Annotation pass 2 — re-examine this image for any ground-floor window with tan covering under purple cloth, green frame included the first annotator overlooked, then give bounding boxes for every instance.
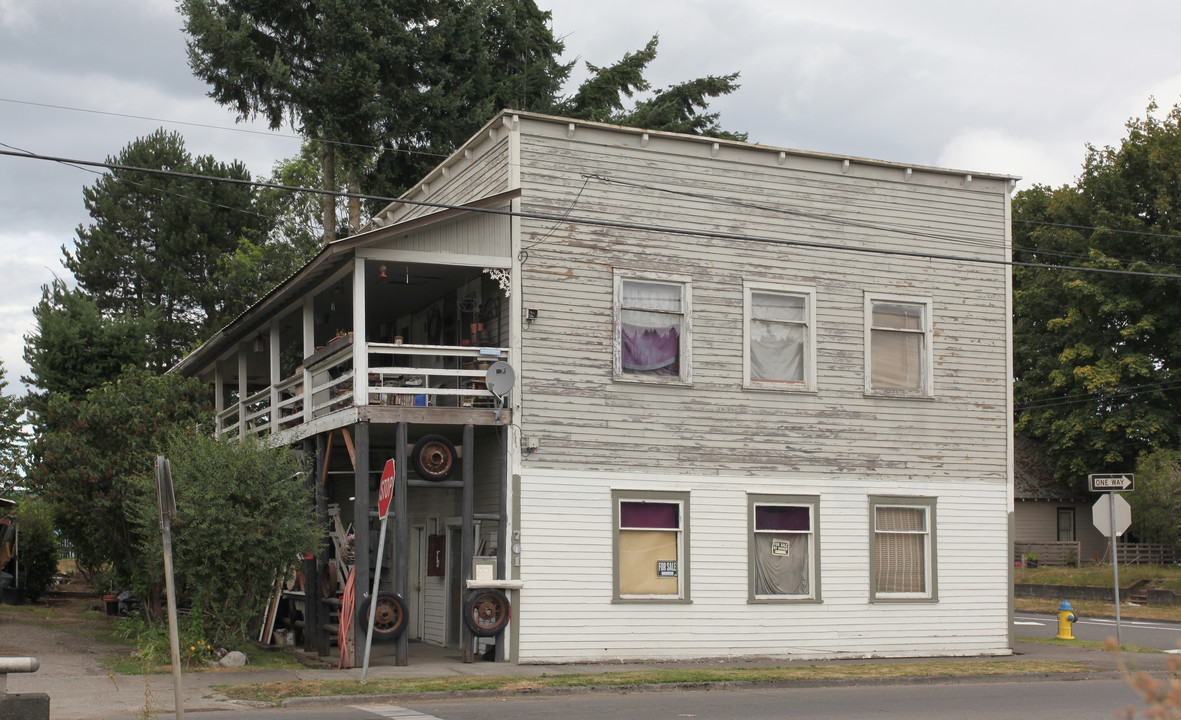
[612,491,689,602]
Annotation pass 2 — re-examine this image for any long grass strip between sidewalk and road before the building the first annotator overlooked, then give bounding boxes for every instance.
[215,660,1090,703]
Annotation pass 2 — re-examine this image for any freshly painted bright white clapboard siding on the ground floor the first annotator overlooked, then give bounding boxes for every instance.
[515,470,1009,662]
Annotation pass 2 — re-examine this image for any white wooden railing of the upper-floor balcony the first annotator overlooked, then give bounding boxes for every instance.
[217,342,509,437]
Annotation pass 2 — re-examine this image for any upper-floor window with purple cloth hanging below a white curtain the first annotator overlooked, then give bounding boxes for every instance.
[615,276,691,382]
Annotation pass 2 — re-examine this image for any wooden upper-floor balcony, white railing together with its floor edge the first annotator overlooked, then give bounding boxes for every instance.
[216,335,511,443]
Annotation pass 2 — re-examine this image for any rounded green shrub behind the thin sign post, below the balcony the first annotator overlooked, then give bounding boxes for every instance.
[135,431,318,643]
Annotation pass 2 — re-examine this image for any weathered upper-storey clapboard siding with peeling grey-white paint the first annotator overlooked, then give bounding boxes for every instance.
[507,123,1009,480]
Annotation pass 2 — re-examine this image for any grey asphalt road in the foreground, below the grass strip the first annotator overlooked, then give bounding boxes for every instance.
[162,680,1141,720]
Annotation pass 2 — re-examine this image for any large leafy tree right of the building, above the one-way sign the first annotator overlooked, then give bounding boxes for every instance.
[1013,97,1181,484]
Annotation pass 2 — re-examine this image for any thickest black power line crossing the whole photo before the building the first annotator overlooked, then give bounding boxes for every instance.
[0,144,1181,280]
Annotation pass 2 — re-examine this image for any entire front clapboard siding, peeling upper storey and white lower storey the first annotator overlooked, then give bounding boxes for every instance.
[503,117,1011,662]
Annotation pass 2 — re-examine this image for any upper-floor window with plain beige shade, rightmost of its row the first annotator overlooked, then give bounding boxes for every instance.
[866,296,933,397]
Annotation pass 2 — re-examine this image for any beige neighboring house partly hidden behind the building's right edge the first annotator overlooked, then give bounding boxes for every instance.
[1013,438,1111,563]
